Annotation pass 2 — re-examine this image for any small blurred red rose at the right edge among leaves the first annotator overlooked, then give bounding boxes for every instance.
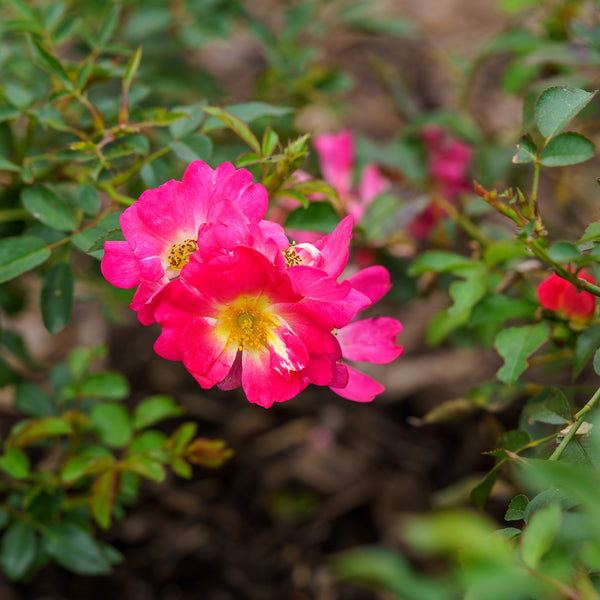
[537,271,596,321]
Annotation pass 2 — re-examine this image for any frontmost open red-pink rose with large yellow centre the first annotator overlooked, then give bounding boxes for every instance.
[154,246,345,408]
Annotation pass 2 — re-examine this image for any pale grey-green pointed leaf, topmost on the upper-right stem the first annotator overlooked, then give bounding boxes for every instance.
[535,86,596,139]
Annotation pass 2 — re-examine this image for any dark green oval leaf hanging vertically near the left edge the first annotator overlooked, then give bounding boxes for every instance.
[40,262,75,334]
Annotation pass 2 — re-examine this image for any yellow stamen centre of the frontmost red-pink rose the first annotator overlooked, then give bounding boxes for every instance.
[217,296,276,350]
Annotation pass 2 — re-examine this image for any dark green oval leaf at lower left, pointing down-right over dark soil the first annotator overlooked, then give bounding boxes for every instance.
[42,523,110,575]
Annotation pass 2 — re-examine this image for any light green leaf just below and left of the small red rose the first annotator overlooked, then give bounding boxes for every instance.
[494,323,550,384]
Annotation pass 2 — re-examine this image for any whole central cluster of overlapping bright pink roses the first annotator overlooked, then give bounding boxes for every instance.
[101,161,402,408]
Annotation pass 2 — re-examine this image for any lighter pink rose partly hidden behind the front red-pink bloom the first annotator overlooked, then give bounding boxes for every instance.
[101,161,268,325]
